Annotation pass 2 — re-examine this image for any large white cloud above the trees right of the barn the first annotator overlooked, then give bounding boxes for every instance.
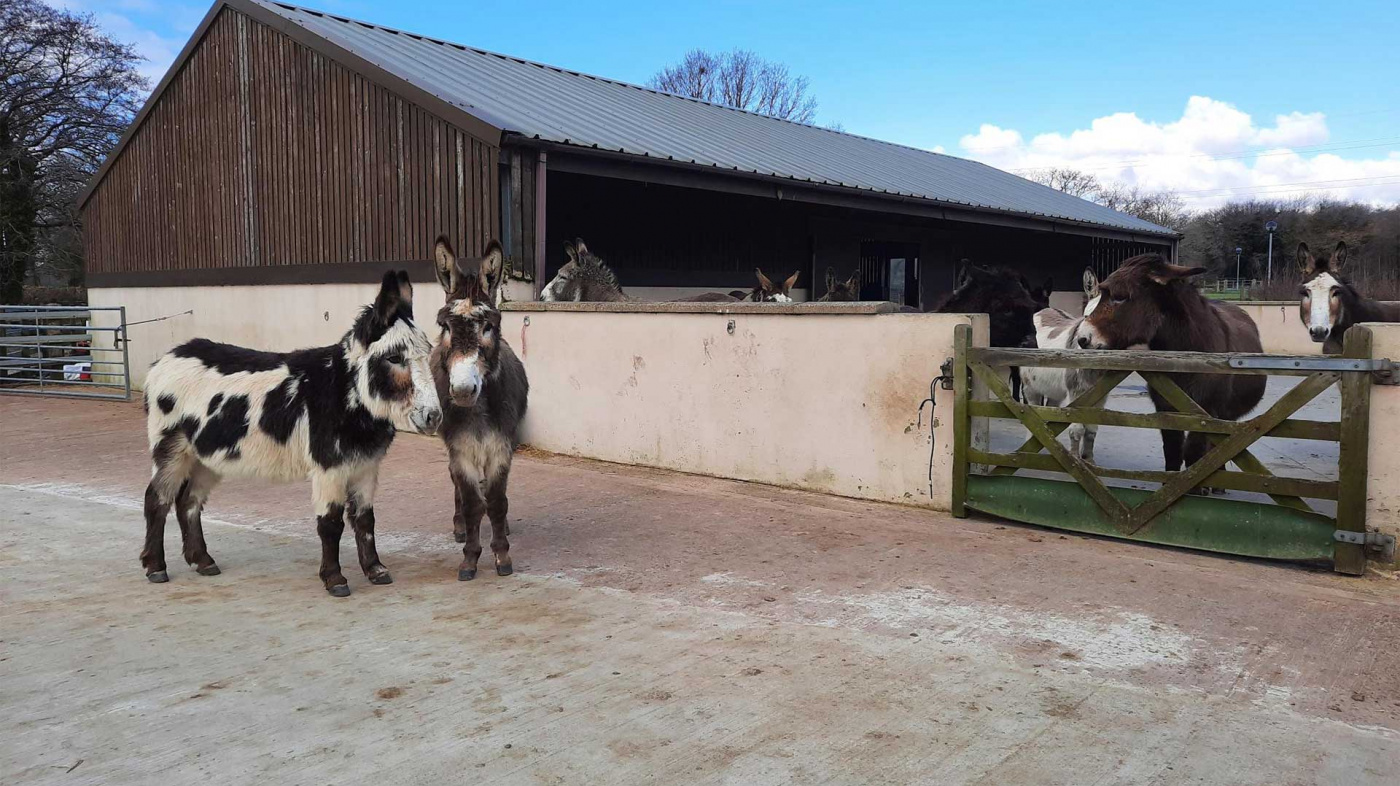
[959,95,1400,207]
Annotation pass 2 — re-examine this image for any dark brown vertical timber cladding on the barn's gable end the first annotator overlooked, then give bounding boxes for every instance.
[84,8,498,284]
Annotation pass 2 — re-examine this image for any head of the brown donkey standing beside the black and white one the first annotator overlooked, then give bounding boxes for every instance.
[433,235,504,406]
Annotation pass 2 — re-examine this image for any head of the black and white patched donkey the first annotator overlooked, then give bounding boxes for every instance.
[342,270,442,434]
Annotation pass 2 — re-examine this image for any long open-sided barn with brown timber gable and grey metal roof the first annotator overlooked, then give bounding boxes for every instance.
[81,0,1177,369]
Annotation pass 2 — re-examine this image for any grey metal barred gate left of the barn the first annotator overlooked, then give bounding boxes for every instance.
[0,305,132,399]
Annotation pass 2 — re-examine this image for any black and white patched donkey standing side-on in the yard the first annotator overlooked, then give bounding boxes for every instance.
[141,270,442,597]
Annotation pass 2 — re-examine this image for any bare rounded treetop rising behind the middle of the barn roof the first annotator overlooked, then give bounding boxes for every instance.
[650,49,816,123]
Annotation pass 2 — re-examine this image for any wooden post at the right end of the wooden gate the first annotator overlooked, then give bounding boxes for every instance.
[1331,325,1371,576]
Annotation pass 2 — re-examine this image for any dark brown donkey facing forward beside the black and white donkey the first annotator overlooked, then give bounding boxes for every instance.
[430,237,529,581]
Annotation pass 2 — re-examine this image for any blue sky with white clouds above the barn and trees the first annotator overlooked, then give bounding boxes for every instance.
[64,0,1400,206]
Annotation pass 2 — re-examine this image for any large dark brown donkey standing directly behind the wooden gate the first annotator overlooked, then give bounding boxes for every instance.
[1079,254,1267,472]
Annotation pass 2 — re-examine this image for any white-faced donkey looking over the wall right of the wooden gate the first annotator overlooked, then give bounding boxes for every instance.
[1298,242,1400,348]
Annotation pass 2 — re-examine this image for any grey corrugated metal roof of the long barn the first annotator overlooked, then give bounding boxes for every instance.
[253,0,1175,235]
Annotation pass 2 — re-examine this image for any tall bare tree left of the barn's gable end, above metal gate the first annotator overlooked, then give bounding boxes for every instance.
[0,0,146,303]
